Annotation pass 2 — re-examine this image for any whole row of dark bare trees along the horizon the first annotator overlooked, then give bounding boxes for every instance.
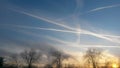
[0,48,119,68]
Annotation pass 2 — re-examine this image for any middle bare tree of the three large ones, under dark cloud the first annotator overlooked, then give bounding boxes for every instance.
[51,50,70,68]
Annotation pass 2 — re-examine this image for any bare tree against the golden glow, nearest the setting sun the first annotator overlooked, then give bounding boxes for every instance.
[84,48,102,68]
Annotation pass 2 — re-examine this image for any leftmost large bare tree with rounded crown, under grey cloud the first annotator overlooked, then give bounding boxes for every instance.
[21,49,41,68]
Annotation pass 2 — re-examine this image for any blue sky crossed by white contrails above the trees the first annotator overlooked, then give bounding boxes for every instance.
[0,0,120,55]
